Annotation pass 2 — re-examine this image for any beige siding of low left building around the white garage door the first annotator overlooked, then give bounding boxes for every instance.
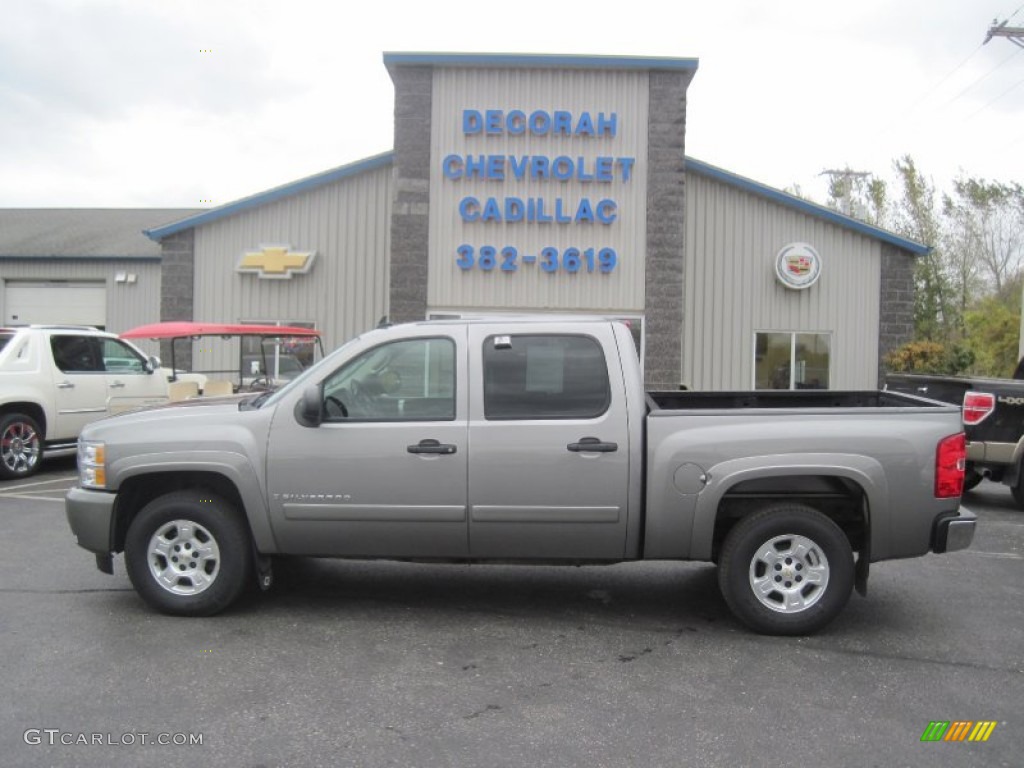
[0,259,160,342]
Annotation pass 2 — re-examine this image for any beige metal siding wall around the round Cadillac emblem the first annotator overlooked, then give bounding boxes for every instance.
[683,173,882,390]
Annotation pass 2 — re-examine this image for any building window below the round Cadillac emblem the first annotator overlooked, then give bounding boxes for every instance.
[754,331,831,389]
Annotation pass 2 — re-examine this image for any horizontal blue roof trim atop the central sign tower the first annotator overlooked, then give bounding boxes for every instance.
[384,52,699,71]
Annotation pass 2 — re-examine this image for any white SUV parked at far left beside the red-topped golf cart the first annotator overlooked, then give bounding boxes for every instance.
[0,326,167,479]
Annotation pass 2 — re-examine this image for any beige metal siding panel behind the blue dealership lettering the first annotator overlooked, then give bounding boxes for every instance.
[427,69,648,311]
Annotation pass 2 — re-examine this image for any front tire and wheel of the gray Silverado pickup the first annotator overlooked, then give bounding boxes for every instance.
[125,489,252,616]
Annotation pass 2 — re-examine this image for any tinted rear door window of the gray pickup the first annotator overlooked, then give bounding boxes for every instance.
[483,335,611,420]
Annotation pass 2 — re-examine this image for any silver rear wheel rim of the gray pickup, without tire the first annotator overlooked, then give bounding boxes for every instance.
[750,534,828,613]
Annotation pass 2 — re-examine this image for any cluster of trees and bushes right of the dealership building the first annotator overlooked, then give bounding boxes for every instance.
[811,155,1024,376]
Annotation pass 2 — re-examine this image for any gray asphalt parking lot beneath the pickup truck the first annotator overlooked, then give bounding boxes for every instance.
[0,461,1024,768]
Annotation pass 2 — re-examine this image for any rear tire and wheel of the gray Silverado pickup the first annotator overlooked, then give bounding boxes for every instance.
[718,504,854,635]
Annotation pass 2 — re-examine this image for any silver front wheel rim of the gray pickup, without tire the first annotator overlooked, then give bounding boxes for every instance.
[148,520,220,595]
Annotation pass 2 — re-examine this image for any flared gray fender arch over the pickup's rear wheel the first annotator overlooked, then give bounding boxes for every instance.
[690,453,890,560]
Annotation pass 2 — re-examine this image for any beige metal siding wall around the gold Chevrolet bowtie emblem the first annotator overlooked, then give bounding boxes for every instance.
[194,167,391,369]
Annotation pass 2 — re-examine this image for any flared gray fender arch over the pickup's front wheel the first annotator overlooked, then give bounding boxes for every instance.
[111,451,278,553]
